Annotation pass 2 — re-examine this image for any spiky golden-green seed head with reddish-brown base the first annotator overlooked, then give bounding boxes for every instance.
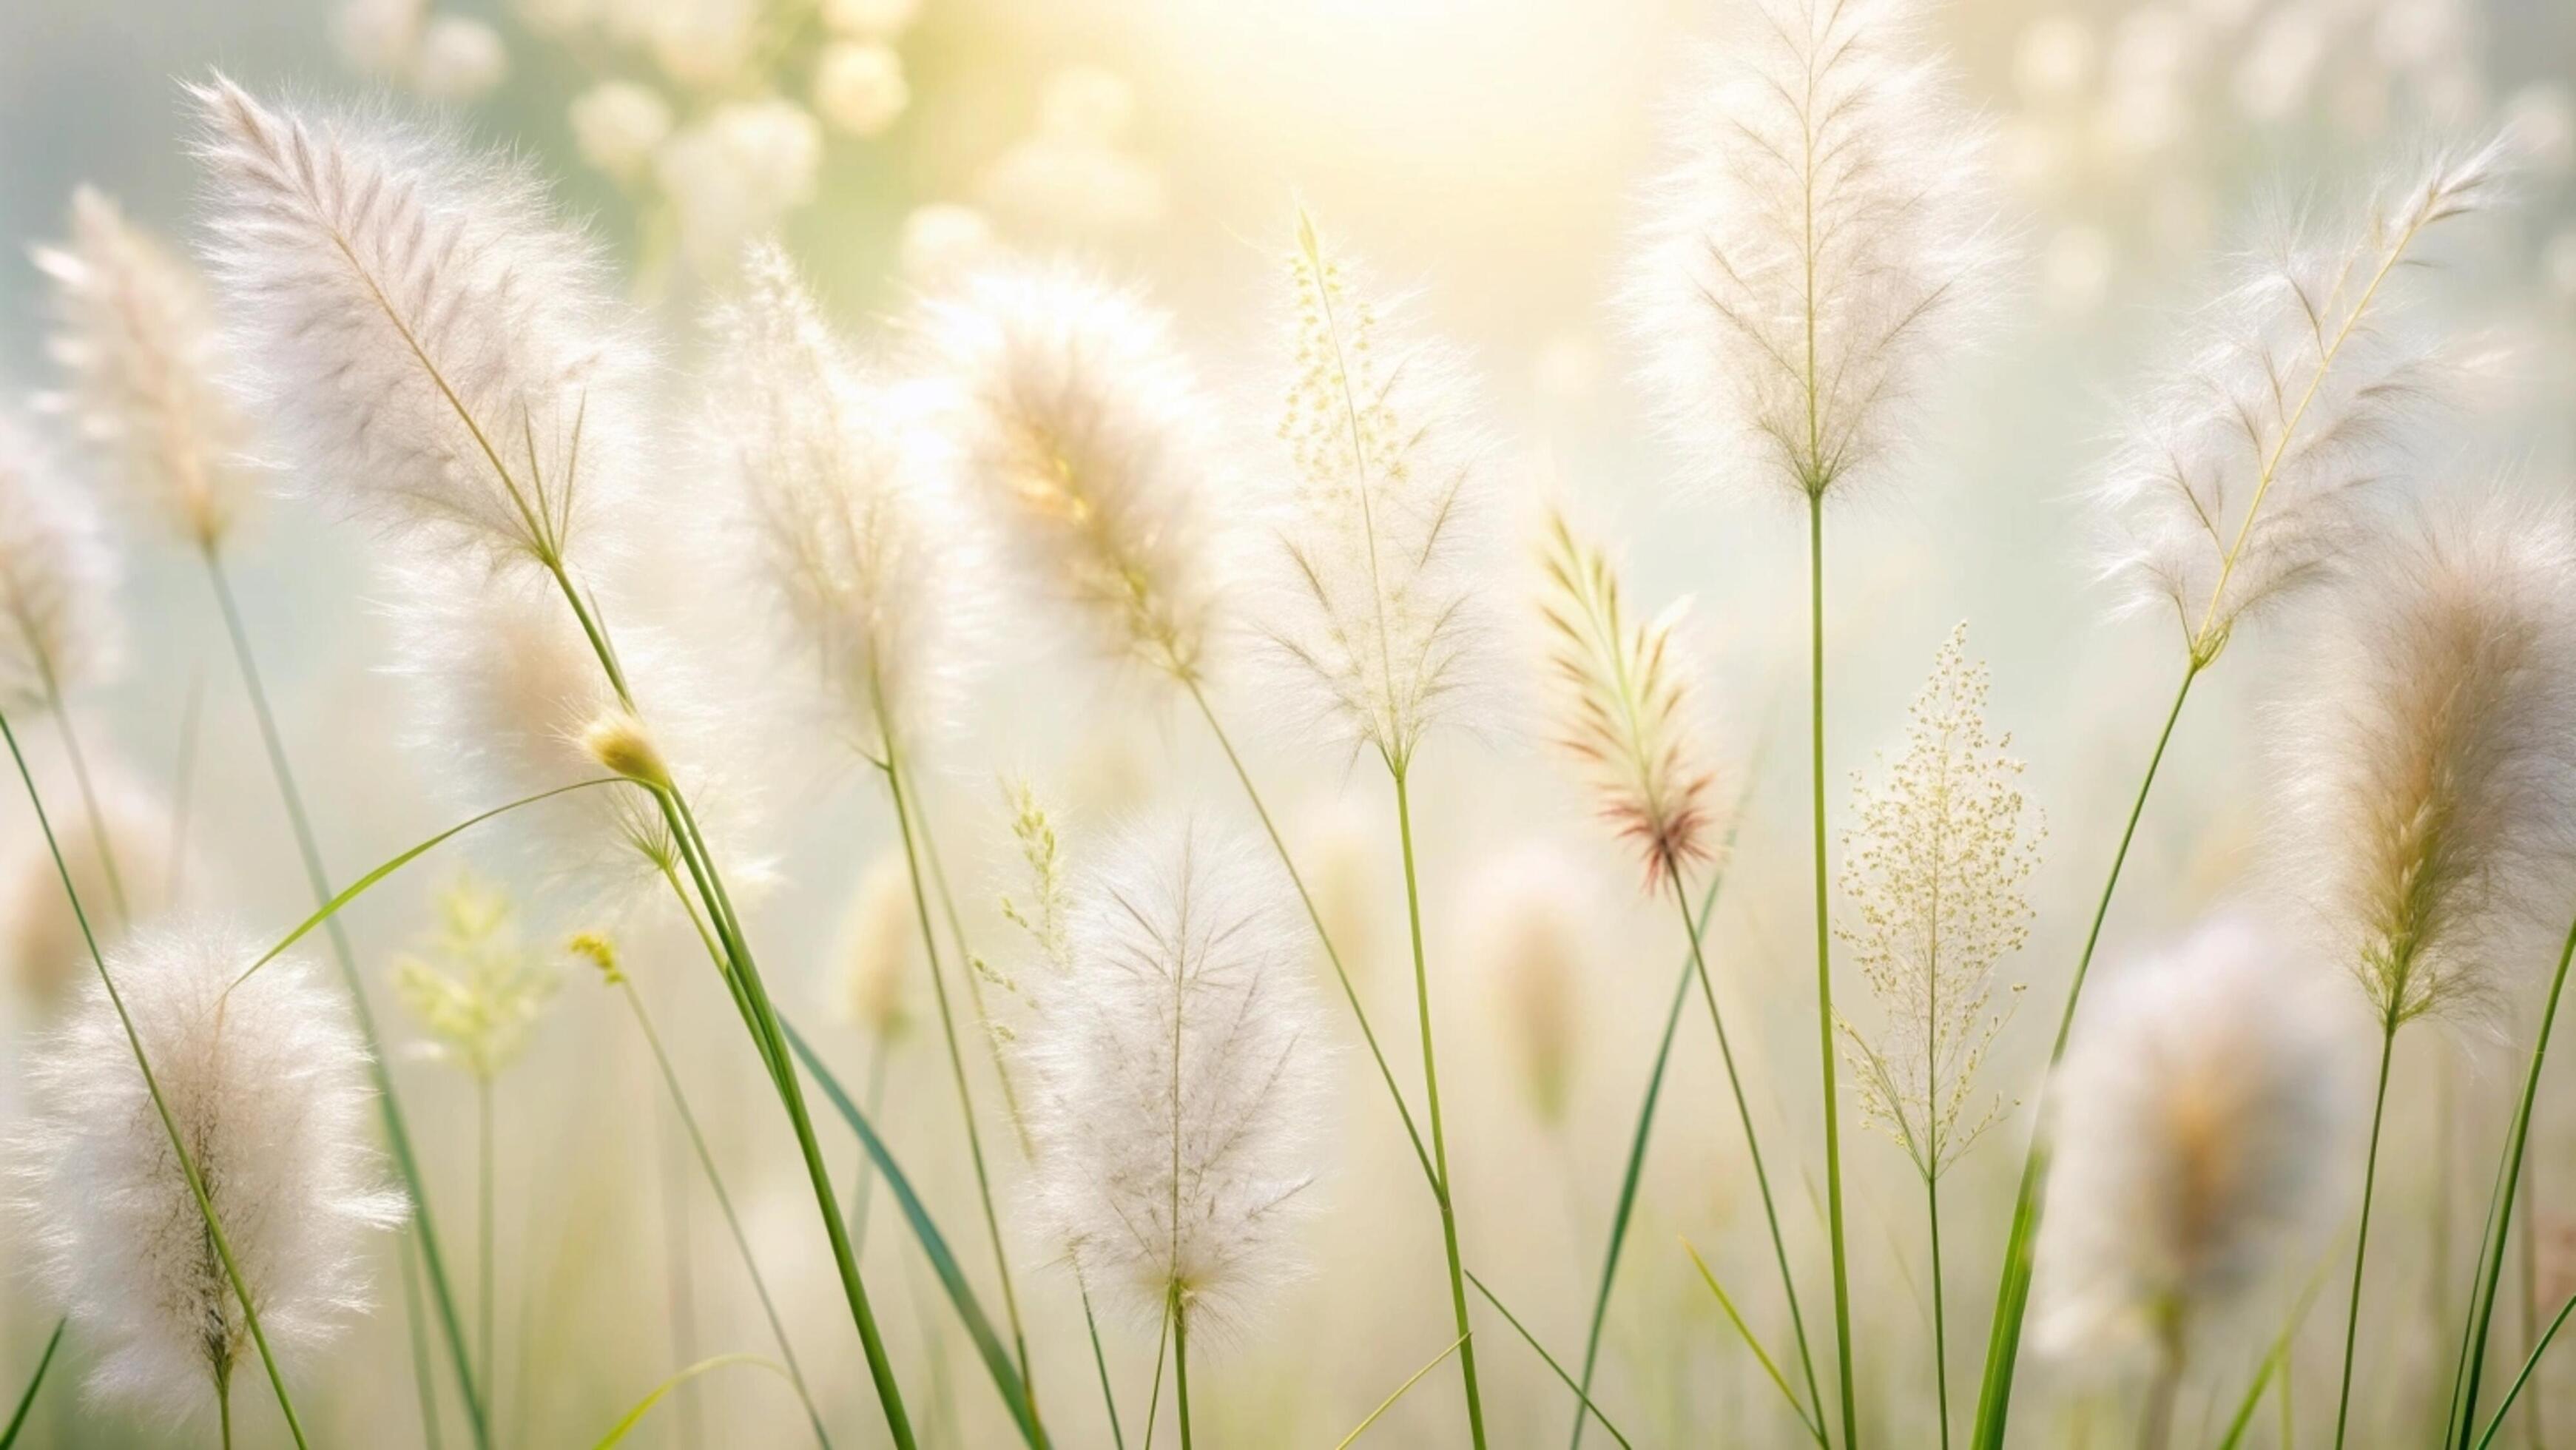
[1538,510,1716,888]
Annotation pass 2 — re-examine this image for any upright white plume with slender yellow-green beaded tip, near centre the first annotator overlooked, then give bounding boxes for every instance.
[1265,211,1489,772]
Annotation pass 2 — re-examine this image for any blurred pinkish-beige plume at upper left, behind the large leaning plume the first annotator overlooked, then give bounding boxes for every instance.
[36,186,252,549]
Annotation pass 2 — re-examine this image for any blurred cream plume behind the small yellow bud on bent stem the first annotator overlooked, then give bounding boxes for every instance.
[389,556,760,899]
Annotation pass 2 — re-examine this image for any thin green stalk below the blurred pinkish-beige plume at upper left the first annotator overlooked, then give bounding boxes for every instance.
[198,546,492,1450]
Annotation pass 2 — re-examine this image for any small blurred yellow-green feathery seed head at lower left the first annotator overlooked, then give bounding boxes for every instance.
[394,876,562,1082]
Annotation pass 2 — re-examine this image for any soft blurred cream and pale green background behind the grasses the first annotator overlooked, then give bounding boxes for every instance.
[0,0,2576,1445]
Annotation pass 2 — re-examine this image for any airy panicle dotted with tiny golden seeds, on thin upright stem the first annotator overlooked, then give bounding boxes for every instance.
[1837,623,2048,1177]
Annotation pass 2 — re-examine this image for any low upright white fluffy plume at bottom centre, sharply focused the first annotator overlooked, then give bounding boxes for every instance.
[1020,822,1326,1332]
